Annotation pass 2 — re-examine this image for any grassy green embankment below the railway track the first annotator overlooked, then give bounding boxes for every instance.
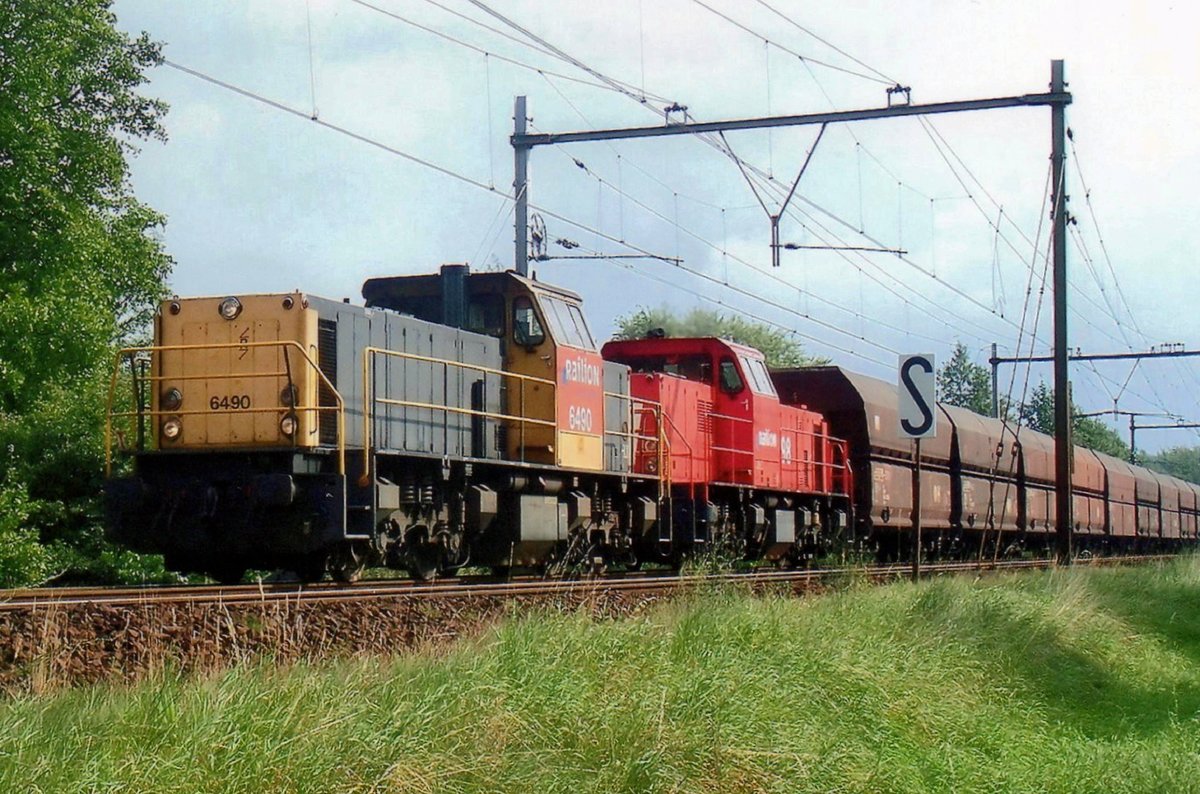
[0,559,1200,792]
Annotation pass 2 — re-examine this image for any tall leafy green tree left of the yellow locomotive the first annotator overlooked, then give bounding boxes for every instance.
[0,0,172,582]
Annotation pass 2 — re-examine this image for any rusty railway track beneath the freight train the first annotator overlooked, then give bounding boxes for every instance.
[0,554,1171,610]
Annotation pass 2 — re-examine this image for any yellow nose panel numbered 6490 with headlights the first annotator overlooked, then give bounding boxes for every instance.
[151,293,319,449]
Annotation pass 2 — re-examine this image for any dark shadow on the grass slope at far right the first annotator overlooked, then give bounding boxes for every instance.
[912,575,1200,739]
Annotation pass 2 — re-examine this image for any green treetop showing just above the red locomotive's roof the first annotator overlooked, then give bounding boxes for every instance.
[616,306,829,368]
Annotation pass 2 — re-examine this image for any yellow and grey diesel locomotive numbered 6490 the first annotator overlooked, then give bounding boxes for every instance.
[106,265,665,582]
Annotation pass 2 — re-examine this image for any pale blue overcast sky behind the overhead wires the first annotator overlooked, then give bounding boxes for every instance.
[115,0,1200,450]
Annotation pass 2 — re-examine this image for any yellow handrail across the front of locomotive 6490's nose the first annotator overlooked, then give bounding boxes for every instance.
[104,339,346,476]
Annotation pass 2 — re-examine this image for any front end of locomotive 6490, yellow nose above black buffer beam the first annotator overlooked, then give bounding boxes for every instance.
[106,293,346,581]
